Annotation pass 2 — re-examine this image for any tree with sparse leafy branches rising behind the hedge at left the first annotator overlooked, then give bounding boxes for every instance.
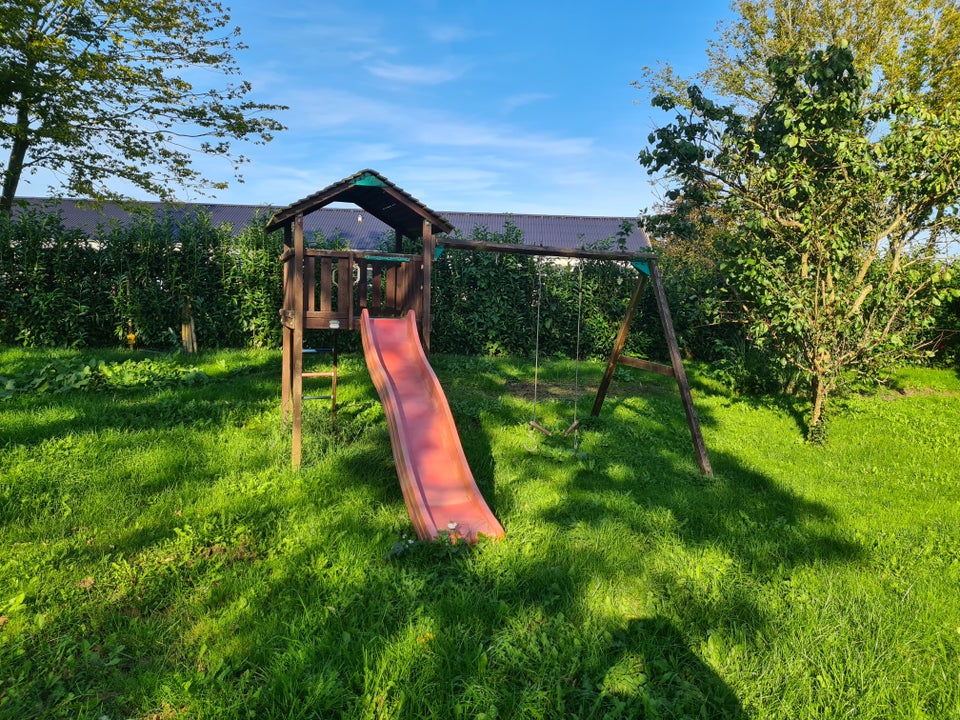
[0,0,284,212]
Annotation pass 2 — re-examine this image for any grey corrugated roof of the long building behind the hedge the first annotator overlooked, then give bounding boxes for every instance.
[14,198,649,251]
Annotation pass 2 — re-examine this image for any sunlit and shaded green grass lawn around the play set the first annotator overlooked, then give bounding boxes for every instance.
[0,349,960,720]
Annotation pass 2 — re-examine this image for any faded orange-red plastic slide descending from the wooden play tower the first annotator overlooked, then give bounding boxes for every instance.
[361,309,503,543]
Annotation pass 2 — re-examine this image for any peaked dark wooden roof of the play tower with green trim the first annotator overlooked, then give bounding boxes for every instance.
[267,170,453,238]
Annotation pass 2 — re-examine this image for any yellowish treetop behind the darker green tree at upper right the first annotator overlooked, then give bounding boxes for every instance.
[637,0,960,111]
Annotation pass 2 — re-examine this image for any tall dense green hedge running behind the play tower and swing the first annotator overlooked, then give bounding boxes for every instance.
[0,210,683,357]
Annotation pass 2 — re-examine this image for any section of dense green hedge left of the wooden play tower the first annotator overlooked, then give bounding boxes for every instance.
[0,208,282,347]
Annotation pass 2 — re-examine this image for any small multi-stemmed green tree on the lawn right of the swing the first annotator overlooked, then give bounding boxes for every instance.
[640,42,960,439]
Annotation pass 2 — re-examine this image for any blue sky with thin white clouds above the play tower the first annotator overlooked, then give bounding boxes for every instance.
[30,0,729,216]
